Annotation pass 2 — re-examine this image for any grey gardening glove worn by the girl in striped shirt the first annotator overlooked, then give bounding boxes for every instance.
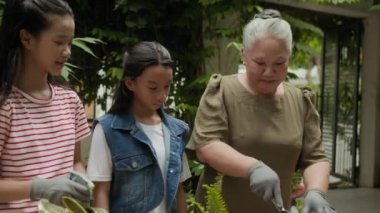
[30,176,90,205]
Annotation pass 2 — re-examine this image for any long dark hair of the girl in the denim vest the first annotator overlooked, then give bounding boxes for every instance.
[108,41,174,114]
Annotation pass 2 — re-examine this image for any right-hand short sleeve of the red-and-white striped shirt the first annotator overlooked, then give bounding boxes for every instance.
[75,95,91,141]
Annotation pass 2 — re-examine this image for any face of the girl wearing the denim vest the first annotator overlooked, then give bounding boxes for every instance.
[124,65,173,112]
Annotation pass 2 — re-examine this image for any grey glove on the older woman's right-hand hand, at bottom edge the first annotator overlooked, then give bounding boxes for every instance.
[302,189,336,213]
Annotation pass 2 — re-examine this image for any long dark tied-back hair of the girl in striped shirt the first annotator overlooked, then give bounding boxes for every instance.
[0,0,74,104]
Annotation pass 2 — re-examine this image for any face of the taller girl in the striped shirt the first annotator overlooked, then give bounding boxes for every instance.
[22,15,75,75]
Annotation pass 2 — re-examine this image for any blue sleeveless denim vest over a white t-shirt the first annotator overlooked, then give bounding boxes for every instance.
[94,109,189,213]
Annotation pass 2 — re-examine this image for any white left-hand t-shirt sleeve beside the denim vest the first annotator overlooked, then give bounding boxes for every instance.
[87,124,112,181]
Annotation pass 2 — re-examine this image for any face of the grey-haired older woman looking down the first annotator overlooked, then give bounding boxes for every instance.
[243,36,290,96]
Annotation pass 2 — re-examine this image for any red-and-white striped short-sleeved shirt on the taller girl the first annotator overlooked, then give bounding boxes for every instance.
[0,85,90,212]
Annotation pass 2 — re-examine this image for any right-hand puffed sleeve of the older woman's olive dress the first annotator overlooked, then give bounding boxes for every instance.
[298,89,328,170]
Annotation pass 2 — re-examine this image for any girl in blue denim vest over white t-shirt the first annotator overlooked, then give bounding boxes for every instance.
[87,42,191,213]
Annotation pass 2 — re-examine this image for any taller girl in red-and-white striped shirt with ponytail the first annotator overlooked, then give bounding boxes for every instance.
[0,0,90,212]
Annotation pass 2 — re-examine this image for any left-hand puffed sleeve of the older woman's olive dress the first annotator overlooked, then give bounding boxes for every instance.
[187,74,228,150]
